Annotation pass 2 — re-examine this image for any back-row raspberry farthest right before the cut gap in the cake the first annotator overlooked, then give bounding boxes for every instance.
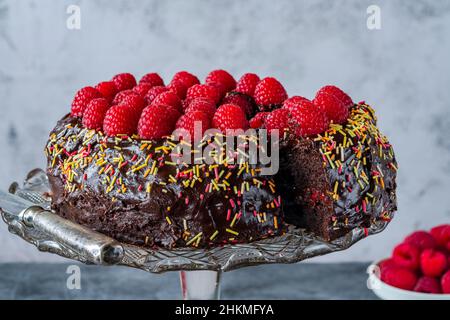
[254,77,287,111]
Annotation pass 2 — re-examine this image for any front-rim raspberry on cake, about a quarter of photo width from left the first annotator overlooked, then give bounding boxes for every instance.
[103,104,138,136]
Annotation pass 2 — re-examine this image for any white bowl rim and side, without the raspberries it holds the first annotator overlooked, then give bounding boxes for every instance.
[367,261,450,300]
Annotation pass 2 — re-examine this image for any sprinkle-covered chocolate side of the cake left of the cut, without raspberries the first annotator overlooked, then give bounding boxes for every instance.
[46,116,284,248]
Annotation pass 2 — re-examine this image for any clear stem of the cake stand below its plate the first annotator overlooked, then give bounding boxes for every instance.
[180,270,221,300]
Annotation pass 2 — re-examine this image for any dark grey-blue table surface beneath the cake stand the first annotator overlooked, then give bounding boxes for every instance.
[0,263,376,300]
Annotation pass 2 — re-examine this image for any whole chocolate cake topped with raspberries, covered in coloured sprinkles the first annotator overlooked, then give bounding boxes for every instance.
[45,70,397,248]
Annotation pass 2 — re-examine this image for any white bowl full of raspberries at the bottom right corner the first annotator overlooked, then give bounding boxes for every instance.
[368,224,450,300]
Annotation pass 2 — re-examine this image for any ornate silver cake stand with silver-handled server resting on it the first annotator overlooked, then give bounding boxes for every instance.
[0,169,387,299]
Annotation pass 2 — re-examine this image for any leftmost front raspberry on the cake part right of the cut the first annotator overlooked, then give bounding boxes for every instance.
[290,101,330,137]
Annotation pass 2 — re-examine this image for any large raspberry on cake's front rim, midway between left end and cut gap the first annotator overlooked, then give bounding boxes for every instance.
[138,104,179,140]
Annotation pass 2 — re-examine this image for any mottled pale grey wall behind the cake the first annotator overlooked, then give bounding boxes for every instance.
[0,0,450,262]
